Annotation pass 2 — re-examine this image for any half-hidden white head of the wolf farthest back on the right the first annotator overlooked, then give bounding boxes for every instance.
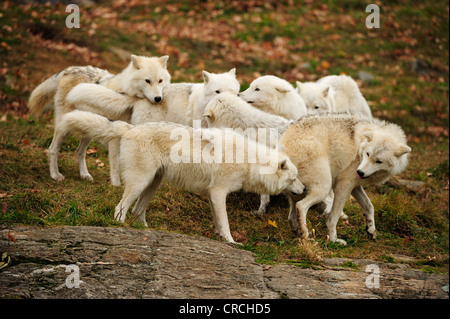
[297,81,333,114]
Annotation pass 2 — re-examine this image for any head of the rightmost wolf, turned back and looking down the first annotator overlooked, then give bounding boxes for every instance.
[356,124,411,183]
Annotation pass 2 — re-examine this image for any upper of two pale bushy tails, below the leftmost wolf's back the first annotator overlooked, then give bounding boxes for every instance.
[66,83,136,119]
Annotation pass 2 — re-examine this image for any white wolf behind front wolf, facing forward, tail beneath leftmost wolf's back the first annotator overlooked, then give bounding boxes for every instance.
[67,69,239,185]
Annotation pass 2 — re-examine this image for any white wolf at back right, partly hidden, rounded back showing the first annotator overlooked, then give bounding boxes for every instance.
[297,75,372,119]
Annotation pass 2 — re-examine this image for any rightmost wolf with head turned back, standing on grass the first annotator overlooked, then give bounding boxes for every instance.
[280,115,411,244]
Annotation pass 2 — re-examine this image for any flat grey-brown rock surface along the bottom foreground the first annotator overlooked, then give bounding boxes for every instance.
[0,227,448,299]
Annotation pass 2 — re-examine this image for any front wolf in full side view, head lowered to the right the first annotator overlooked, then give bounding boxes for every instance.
[57,111,304,243]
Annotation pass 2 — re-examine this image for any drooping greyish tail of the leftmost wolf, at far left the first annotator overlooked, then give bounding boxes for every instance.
[28,72,60,115]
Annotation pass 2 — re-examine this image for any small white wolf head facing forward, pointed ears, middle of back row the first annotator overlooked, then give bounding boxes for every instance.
[203,68,240,105]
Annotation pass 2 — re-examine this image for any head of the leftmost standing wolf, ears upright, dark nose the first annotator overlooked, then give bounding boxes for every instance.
[126,55,170,103]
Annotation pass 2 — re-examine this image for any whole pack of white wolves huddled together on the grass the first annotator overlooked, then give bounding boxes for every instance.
[28,55,411,245]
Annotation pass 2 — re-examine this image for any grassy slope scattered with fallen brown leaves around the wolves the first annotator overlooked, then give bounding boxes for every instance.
[0,0,449,272]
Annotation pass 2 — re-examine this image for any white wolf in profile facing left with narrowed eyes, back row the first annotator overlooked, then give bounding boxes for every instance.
[239,75,307,120]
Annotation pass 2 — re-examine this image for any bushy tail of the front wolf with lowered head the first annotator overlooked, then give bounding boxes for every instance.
[56,110,133,142]
